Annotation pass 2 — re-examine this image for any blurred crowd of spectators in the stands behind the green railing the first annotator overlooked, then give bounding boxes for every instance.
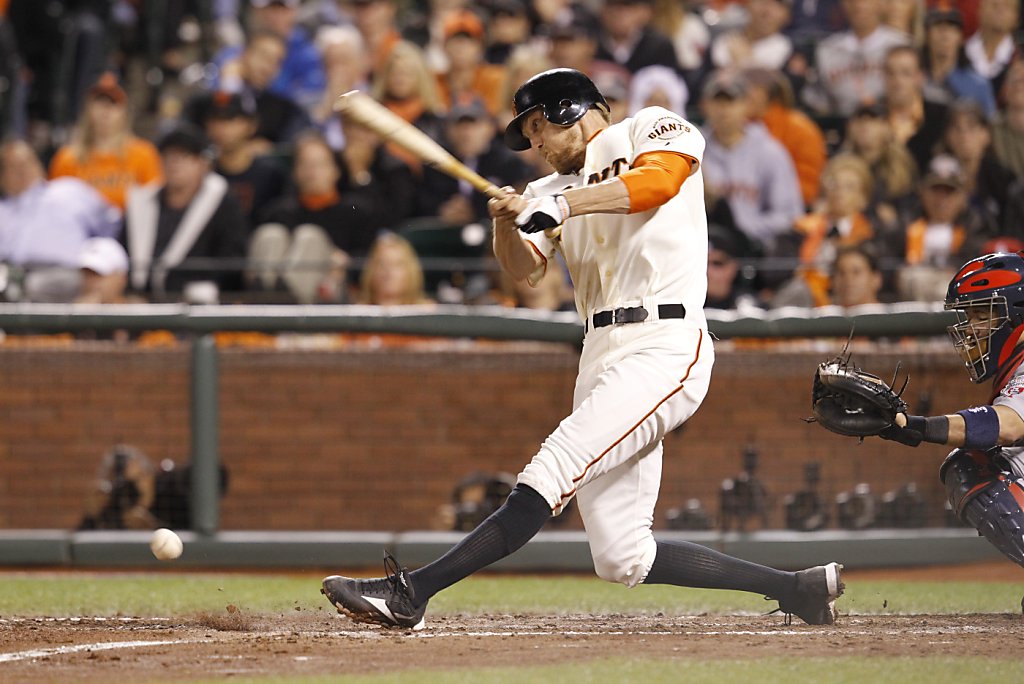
[0,0,1024,310]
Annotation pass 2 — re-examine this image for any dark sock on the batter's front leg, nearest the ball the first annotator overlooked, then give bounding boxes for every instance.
[409,484,551,605]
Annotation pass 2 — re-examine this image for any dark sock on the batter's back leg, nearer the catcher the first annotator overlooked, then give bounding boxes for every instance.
[644,542,796,598]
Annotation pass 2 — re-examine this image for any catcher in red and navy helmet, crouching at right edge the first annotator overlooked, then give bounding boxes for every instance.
[880,252,1024,565]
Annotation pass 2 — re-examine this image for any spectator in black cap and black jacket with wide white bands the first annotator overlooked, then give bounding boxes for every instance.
[123,124,248,302]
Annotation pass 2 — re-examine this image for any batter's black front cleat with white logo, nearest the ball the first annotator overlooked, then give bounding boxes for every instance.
[321,552,427,630]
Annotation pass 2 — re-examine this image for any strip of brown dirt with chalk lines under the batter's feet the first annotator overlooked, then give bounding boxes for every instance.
[0,611,1022,682]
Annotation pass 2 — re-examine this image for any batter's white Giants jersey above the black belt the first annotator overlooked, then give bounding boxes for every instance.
[523,106,708,327]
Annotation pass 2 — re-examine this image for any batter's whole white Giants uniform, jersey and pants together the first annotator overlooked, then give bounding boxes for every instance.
[518,108,715,587]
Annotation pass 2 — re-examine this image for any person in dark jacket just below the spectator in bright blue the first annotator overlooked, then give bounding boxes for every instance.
[197,32,309,153]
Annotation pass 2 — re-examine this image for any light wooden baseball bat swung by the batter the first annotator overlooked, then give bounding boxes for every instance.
[334,90,505,198]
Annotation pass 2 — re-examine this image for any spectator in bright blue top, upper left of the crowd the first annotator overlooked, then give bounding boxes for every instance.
[241,0,327,110]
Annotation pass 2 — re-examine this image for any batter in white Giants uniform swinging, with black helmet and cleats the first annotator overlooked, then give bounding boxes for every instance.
[323,69,843,629]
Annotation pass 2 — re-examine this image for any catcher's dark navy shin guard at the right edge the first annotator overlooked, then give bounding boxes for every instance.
[939,448,1024,566]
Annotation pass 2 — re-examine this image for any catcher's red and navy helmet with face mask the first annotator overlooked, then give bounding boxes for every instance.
[945,252,1024,382]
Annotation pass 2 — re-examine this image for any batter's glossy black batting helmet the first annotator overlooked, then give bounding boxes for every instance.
[505,69,609,152]
